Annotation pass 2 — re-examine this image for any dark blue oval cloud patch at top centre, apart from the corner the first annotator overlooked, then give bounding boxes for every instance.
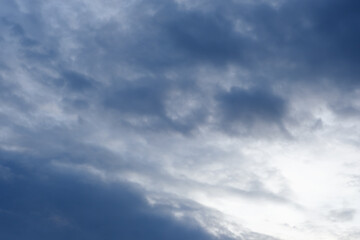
[166,12,245,64]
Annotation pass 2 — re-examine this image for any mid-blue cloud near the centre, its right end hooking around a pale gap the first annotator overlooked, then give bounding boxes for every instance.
[103,78,206,134]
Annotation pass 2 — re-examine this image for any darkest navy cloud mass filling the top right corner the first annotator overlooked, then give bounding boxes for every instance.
[236,1,360,87]
